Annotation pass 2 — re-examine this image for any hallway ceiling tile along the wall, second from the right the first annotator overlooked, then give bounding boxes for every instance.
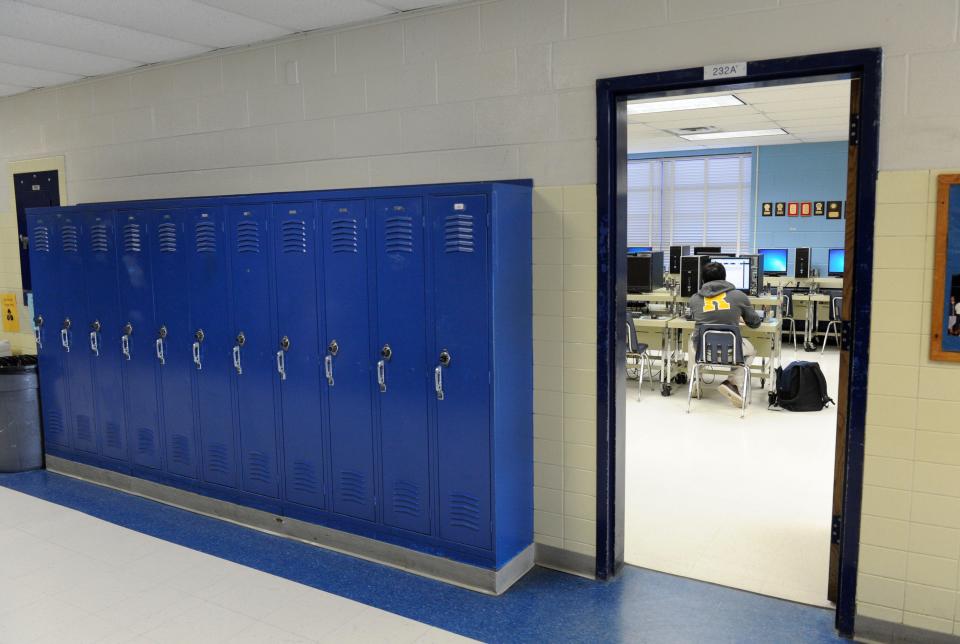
[198,0,393,31]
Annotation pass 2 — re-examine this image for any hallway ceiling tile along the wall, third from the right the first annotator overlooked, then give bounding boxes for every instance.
[21,0,290,48]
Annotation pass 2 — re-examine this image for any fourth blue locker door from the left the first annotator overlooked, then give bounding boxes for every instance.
[116,211,163,469]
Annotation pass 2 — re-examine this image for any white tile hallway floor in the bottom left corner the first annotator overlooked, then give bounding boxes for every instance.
[0,487,471,644]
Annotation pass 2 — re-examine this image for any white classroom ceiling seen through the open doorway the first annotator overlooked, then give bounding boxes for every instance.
[627,80,850,152]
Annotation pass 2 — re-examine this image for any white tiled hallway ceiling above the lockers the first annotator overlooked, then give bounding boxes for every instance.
[0,0,456,96]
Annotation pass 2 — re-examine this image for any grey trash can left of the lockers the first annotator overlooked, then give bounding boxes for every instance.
[0,356,43,472]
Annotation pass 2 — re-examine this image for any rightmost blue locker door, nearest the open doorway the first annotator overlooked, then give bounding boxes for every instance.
[429,195,492,548]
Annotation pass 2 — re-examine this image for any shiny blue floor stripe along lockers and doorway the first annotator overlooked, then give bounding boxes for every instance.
[0,471,844,643]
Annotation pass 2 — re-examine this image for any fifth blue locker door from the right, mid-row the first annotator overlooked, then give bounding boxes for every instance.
[227,204,280,498]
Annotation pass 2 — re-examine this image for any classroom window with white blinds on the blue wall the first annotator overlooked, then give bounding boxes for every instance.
[627,154,753,253]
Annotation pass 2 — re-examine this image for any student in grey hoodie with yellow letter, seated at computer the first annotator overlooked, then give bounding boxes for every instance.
[687,262,762,407]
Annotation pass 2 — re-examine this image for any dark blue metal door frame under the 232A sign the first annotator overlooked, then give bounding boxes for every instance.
[596,48,882,637]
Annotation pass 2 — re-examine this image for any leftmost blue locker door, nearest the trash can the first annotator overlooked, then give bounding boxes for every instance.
[29,215,69,448]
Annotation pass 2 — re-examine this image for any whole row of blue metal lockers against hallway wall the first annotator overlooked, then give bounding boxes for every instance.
[28,181,533,568]
